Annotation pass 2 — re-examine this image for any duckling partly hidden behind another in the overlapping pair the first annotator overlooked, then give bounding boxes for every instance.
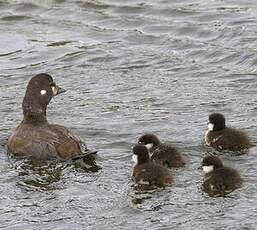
[138,133,185,167]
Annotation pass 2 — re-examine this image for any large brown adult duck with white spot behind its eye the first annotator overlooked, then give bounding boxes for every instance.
[8,73,95,160]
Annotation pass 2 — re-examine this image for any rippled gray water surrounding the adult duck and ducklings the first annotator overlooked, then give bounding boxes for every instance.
[0,0,257,230]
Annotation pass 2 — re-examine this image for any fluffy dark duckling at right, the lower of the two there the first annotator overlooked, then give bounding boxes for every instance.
[200,154,242,191]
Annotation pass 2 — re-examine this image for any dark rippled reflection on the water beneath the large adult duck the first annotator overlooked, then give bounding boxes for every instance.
[10,155,101,191]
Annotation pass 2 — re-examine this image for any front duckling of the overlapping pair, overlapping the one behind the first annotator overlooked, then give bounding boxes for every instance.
[132,144,173,186]
